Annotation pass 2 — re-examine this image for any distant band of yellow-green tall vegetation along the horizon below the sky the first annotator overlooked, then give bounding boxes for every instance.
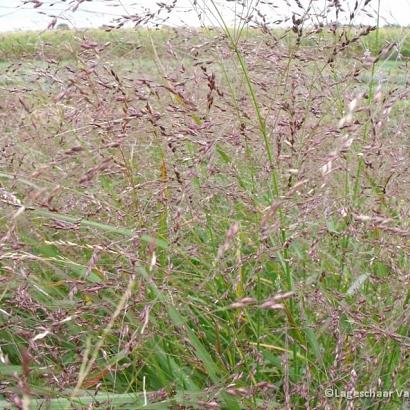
[0,27,410,61]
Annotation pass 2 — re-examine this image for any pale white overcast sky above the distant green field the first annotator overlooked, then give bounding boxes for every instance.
[0,0,410,31]
